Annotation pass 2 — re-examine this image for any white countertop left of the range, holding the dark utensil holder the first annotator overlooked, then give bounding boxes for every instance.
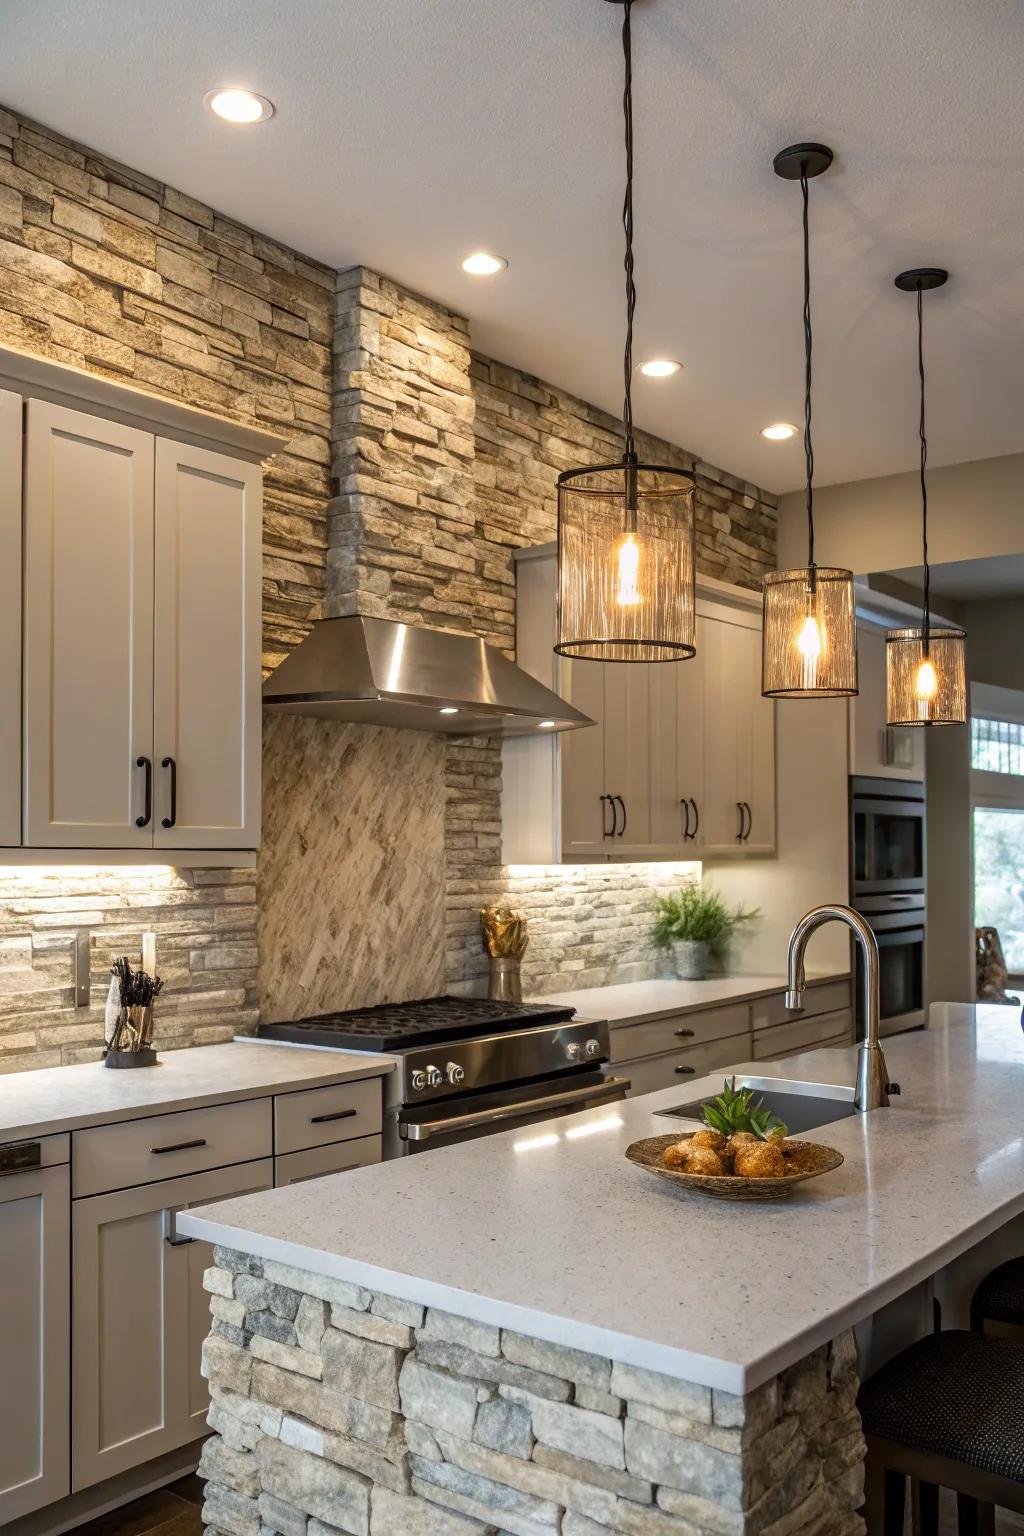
[0,1041,395,1141]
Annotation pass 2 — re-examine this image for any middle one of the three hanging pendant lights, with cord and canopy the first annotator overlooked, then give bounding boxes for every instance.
[761,144,857,699]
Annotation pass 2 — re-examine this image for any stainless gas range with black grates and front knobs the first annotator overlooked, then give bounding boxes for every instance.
[256,997,629,1155]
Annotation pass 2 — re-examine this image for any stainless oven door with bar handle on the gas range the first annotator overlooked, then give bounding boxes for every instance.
[398,1072,629,1152]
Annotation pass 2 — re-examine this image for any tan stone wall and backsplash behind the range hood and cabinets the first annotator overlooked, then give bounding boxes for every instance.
[0,109,775,1071]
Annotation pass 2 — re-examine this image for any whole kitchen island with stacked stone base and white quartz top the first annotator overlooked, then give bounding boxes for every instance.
[180,1005,1024,1536]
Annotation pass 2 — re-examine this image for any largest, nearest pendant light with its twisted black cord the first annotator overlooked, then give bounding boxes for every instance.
[554,0,695,662]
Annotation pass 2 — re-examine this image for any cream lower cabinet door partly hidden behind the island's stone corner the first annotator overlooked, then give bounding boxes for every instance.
[71,1161,273,1491]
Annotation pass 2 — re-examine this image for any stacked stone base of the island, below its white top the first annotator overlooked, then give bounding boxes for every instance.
[200,1249,864,1536]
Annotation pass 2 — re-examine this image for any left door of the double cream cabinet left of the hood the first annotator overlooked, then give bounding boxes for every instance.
[25,399,154,848]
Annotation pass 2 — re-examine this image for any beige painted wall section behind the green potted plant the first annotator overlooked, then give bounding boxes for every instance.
[703,699,849,972]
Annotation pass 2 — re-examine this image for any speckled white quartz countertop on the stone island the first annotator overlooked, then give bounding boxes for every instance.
[178,1005,1024,1393]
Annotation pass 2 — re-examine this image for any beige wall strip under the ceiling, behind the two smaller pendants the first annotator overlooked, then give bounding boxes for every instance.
[778,453,1024,576]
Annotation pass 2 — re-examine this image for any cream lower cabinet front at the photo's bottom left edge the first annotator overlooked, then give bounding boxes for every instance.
[0,1135,69,1530]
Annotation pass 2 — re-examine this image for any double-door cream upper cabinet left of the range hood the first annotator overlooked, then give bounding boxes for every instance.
[23,399,261,849]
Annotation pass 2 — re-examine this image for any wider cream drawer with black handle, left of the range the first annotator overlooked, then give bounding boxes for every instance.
[71,1098,273,1200]
